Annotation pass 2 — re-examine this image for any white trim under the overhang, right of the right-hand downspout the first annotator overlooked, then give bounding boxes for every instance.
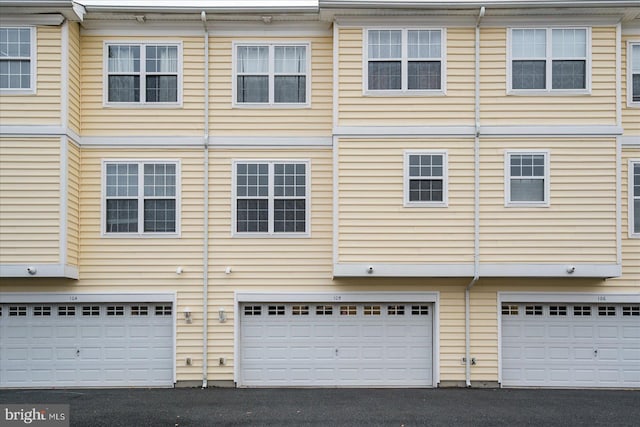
[480,264,622,279]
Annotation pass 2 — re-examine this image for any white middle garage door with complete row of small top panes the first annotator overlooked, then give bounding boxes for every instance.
[239,303,433,387]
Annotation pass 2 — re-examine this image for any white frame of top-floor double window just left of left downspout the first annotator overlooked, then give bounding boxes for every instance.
[102,40,184,108]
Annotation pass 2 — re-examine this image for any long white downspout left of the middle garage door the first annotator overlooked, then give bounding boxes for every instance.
[200,10,209,388]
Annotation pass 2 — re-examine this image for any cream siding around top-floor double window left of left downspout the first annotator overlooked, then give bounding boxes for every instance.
[81,35,204,136]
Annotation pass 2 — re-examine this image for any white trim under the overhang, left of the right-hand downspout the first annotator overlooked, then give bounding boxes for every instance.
[333,263,473,277]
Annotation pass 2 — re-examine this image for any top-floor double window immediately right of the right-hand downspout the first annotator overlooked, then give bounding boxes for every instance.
[507,28,591,93]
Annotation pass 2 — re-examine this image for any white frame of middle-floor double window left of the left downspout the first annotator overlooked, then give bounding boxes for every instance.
[100,159,182,239]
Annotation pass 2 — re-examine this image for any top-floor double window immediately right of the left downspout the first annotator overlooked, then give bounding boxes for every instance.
[233,43,311,107]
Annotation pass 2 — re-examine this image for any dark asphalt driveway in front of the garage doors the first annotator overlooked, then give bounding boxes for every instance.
[0,388,640,427]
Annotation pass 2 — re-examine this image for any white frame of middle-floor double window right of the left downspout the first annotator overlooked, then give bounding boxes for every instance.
[231,159,311,238]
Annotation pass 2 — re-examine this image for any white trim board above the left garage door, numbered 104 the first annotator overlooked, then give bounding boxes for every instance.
[0,292,175,304]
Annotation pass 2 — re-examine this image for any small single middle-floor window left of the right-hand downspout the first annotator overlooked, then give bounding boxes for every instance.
[404,151,448,207]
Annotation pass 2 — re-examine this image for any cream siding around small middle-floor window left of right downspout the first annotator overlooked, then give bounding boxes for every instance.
[338,139,474,264]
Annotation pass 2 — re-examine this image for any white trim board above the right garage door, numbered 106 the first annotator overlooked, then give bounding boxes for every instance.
[498,292,640,303]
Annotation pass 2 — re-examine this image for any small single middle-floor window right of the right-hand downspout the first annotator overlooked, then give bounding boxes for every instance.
[504,150,550,207]
